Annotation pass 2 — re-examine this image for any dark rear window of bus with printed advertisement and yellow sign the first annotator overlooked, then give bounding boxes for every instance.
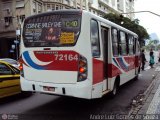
[23,14,81,47]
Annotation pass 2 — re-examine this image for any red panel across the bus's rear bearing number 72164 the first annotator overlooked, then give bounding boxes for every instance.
[23,51,79,71]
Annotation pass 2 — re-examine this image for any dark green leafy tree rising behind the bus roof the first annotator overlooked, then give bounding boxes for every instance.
[104,13,149,46]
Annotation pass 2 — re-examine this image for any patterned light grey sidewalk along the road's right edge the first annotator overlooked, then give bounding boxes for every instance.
[129,63,160,120]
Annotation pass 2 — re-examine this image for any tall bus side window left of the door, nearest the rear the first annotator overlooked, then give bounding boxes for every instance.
[91,20,100,57]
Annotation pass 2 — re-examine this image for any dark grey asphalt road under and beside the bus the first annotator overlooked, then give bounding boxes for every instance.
[0,51,156,120]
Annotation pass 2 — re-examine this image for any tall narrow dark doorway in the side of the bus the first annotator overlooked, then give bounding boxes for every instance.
[101,25,109,91]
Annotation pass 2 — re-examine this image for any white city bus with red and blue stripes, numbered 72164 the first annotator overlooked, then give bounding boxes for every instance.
[19,10,140,99]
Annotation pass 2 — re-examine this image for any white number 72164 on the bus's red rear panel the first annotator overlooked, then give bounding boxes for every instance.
[55,54,78,61]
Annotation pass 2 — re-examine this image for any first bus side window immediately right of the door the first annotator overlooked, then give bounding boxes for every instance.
[112,28,118,56]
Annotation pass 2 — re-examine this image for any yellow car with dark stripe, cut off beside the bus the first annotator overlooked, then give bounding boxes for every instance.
[0,60,21,98]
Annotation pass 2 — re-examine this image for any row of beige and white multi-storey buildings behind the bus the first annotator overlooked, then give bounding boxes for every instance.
[0,0,134,59]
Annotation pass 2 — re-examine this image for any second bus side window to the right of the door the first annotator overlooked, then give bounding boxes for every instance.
[119,31,127,55]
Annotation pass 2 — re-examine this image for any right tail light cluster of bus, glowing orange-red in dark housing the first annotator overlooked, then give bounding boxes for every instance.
[77,56,88,82]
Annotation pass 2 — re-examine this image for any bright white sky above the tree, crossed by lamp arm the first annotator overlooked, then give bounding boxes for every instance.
[135,0,160,38]
